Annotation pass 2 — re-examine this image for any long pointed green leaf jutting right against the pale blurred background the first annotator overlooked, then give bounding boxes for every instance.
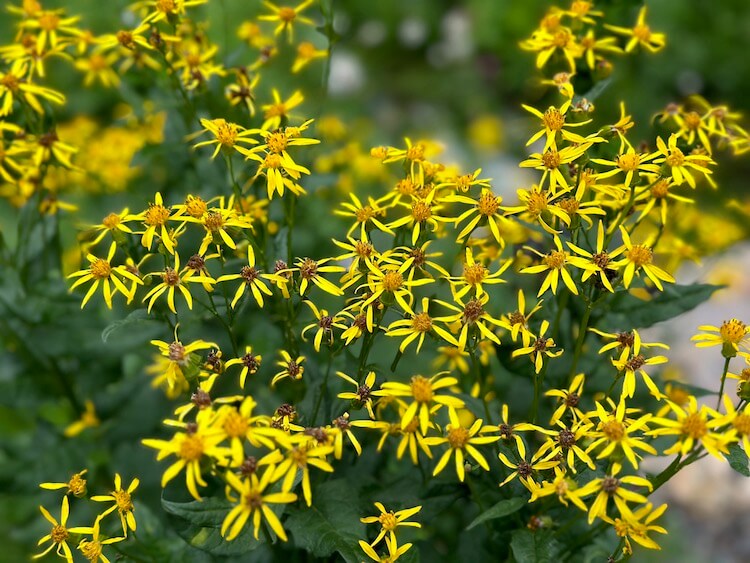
[602,283,722,330]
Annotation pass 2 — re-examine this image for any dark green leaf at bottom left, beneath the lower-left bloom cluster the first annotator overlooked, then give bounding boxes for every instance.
[161,498,264,556]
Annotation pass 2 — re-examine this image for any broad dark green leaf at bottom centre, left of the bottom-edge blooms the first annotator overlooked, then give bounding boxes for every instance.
[286,479,365,563]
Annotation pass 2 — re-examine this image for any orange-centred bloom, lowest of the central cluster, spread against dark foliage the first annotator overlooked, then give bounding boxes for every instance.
[425,407,500,482]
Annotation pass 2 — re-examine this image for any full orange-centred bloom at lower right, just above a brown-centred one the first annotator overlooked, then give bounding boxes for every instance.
[586,397,656,469]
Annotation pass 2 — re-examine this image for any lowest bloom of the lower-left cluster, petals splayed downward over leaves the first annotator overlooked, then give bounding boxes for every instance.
[221,467,297,541]
